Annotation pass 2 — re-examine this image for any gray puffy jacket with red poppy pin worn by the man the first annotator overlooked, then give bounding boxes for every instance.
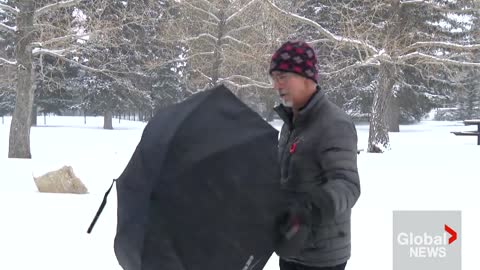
[275,89,360,267]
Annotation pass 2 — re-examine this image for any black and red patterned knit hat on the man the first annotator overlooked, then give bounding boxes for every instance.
[269,41,318,83]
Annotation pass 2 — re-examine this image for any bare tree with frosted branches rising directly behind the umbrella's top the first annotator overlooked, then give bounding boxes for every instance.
[161,0,288,105]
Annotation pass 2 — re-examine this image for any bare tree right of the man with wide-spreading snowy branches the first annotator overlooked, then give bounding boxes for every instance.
[264,0,480,152]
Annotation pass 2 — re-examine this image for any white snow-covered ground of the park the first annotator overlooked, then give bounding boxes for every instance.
[0,117,480,270]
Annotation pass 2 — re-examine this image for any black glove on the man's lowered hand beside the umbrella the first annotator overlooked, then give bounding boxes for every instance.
[275,203,311,257]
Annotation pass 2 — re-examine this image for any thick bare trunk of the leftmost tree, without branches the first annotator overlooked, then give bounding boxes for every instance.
[8,0,34,158]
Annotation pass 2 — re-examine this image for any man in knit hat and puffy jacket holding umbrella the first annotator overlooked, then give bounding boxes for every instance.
[269,42,360,270]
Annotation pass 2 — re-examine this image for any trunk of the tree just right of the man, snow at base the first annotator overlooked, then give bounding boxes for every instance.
[367,63,395,153]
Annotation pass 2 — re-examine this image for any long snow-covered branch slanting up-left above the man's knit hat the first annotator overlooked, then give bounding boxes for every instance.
[265,0,378,54]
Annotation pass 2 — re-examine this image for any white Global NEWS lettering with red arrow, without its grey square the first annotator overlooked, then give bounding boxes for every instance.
[397,224,457,258]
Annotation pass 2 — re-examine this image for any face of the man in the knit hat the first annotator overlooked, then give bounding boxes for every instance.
[271,71,311,109]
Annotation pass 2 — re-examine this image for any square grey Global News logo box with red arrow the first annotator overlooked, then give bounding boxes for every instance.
[392,210,462,270]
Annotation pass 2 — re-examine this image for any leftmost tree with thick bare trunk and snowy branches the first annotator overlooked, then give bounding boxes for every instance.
[0,0,99,158]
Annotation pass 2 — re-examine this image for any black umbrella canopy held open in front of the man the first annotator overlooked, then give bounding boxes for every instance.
[114,86,284,270]
